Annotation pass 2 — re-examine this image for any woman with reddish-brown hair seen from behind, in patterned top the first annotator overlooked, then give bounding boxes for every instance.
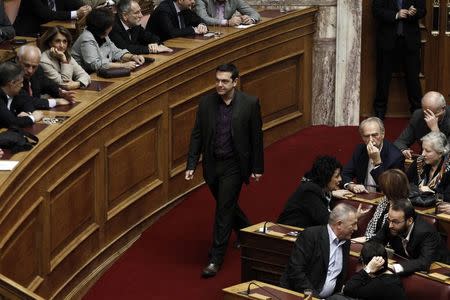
[365,169,409,239]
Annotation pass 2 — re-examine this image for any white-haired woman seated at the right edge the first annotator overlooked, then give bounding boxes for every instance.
[407,131,450,213]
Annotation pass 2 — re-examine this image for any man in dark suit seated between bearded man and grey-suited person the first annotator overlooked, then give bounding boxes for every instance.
[145,0,208,41]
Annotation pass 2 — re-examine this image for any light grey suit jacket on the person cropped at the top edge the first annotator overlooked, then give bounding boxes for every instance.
[195,0,261,25]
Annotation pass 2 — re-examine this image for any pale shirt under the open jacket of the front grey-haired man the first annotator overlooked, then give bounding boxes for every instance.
[319,225,345,298]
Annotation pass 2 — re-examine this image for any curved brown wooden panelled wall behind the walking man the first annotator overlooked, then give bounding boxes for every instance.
[0,8,316,298]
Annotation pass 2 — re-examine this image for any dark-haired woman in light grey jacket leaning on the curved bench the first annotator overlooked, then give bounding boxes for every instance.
[72,8,144,73]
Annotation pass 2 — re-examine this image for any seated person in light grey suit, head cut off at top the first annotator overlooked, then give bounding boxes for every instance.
[195,0,261,26]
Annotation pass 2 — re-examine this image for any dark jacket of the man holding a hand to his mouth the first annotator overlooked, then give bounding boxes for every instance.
[342,140,405,184]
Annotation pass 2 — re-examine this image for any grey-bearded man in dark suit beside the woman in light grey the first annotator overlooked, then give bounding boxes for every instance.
[109,0,172,54]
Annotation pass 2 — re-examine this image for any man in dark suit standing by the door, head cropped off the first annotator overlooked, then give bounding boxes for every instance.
[372,0,426,119]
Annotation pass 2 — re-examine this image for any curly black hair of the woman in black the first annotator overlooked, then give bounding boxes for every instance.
[305,155,342,188]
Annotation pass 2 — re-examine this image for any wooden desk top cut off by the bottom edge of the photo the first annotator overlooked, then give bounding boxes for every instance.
[222,280,317,300]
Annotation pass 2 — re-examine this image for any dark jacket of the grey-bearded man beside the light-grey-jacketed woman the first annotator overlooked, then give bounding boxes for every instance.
[109,16,160,54]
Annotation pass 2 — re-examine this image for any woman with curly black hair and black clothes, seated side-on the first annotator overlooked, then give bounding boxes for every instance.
[277,156,353,227]
